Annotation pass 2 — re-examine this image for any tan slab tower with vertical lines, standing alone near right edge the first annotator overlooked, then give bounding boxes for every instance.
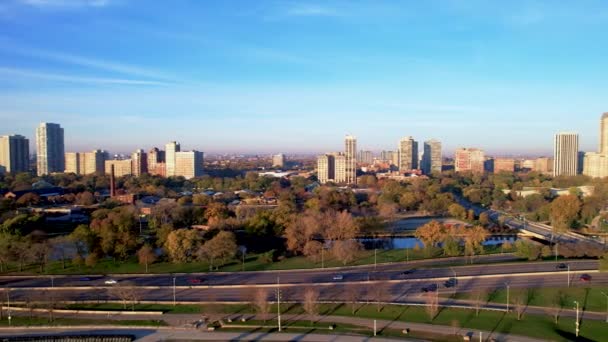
[553,132,579,176]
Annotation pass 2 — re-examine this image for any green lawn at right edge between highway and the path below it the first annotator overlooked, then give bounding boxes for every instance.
[454,286,608,312]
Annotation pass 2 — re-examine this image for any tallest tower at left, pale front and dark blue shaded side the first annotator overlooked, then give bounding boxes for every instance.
[36,122,65,176]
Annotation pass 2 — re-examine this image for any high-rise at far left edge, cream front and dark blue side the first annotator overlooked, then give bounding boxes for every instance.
[0,135,30,173]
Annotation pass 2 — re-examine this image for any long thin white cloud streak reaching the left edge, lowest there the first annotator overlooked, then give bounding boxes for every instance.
[0,67,168,86]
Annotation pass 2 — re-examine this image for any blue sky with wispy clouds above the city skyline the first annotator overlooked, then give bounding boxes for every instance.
[0,0,608,154]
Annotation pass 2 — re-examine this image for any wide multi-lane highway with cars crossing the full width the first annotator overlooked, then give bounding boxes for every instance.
[0,255,608,302]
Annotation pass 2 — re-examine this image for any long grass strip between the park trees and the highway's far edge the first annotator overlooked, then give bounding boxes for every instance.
[2,246,512,275]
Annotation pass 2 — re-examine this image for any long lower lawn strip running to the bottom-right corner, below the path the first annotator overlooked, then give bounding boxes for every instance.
[59,300,608,341]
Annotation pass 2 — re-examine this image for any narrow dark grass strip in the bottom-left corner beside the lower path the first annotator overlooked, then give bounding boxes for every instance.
[0,316,167,327]
